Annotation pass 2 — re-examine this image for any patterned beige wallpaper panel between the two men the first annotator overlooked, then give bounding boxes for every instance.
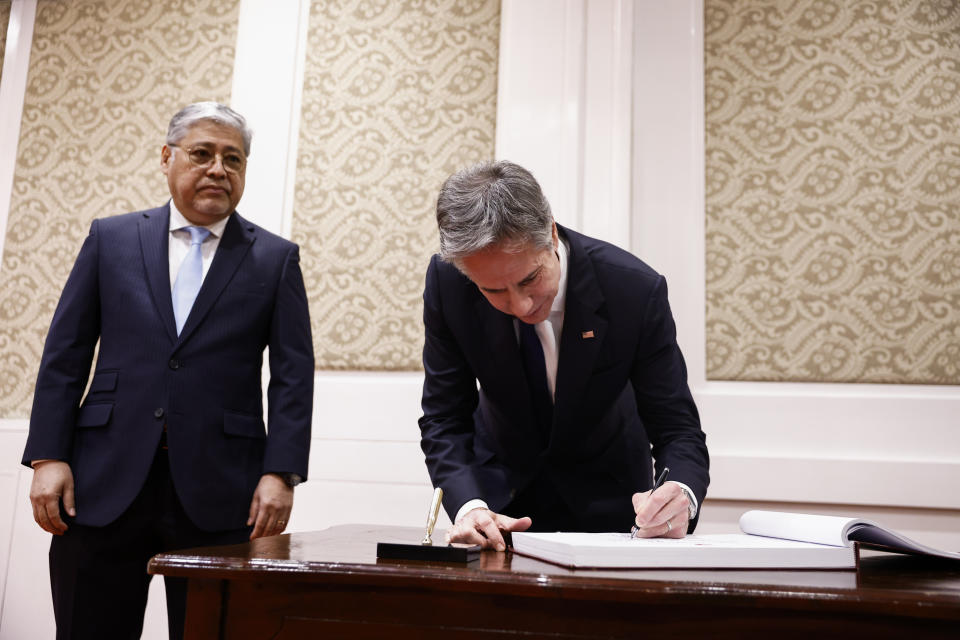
[293,0,500,369]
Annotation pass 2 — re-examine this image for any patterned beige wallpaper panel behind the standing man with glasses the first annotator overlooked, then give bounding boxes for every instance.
[0,0,239,418]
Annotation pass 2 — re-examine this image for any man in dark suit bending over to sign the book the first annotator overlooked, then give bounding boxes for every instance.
[420,162,709,549]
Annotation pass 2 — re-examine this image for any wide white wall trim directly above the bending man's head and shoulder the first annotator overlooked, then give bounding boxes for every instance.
[496,0,634,245]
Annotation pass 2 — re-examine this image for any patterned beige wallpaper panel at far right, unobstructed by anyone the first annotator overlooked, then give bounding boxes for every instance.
[705,0,960,384]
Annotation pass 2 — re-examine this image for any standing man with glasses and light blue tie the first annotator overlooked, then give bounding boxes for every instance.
[23,102,314,639]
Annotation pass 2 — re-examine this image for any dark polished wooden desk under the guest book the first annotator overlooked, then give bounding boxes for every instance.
[149,525,960,640]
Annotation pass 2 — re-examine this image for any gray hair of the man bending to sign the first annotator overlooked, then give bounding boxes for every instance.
[437,160,553,268]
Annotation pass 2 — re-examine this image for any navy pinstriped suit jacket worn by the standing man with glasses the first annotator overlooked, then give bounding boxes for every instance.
[23,204,314,531]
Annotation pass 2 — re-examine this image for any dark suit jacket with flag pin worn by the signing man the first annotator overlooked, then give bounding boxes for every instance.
[420,225,709,531]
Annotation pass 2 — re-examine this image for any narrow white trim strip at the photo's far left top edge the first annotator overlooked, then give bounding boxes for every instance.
[0,0,37,270]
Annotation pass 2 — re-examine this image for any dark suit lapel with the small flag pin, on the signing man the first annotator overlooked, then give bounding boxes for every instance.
[551,228,607,443]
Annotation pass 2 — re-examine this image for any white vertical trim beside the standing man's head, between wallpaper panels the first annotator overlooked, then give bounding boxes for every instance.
[231,0,310,237]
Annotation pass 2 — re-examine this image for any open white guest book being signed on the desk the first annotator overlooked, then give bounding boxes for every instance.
[512,511,960,569]
